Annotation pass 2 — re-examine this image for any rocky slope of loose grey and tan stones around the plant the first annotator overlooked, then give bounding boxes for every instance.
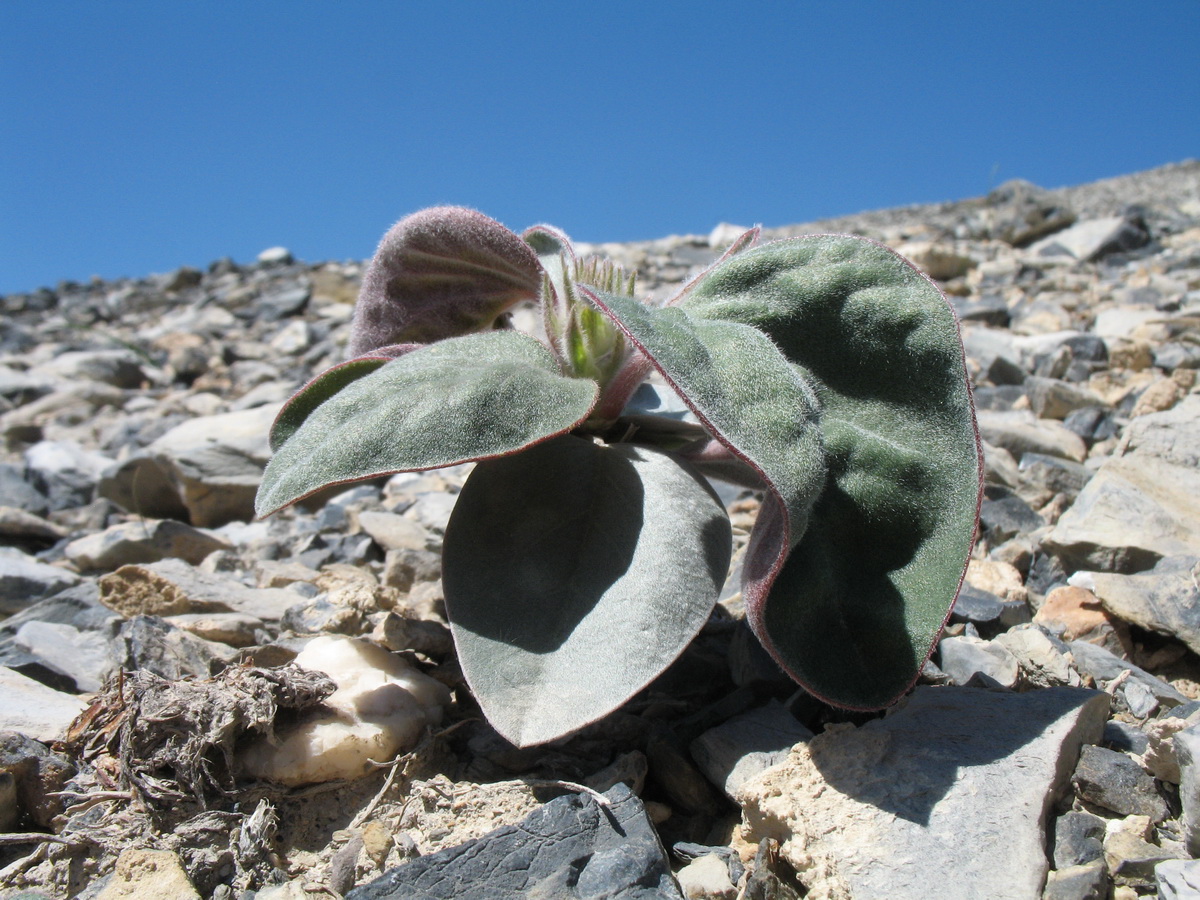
[0,161,1200,900]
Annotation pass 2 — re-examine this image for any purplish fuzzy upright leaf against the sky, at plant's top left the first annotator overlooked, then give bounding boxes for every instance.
[349,206,542,356]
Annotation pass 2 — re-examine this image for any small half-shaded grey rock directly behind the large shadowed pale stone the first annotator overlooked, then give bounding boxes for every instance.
[689,700,812,799]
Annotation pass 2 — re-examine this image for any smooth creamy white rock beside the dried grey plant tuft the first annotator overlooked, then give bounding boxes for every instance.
[241,636,450,785]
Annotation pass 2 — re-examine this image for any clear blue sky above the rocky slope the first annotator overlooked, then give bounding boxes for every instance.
[0,0,1200,294]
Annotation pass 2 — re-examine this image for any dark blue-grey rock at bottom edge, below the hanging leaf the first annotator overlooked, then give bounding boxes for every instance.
[346,785,683,900]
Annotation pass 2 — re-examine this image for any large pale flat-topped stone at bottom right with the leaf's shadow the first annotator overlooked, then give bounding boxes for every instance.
[742,688,1108,900]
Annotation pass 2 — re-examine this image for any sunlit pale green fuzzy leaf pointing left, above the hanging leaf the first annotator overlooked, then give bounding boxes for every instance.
[256,331,599,515]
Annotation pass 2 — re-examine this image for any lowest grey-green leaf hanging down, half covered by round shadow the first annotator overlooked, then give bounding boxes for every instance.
[443,436,731,746]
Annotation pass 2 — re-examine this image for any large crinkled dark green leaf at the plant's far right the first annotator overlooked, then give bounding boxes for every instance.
[679,235,982,708]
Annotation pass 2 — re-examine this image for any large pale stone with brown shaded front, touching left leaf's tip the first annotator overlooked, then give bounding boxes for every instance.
[97,403,281,528]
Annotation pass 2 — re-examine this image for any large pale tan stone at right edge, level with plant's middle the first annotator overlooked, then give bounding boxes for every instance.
[1043,456,1200,572]
